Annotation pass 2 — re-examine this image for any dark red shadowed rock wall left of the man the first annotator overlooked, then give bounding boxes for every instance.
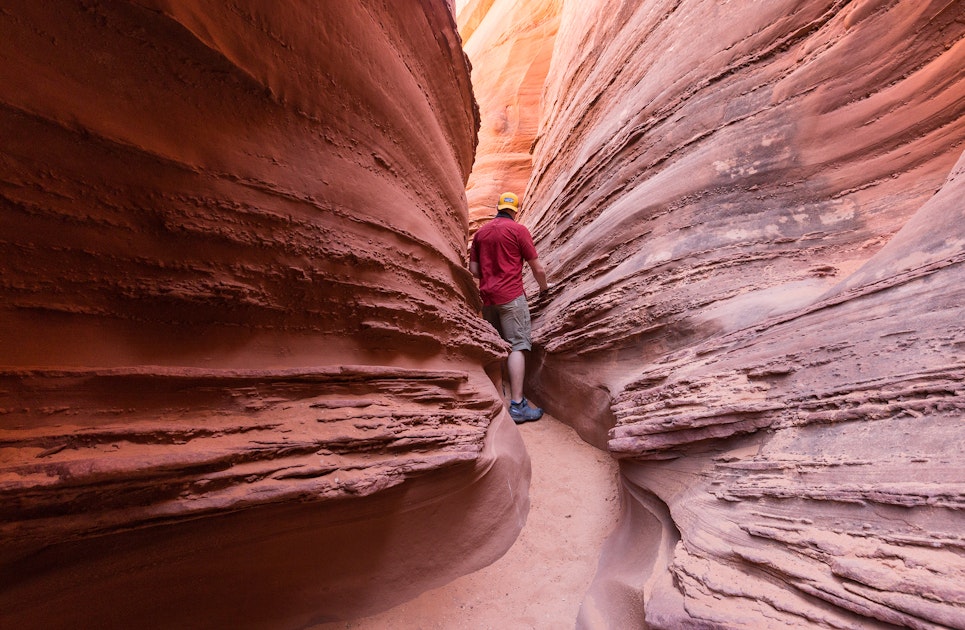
[0,0,528,628]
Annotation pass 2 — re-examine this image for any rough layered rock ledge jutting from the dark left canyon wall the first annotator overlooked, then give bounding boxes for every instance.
[0,366,502,557]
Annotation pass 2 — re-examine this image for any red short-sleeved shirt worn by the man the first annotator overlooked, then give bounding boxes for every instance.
[469,215,537,306]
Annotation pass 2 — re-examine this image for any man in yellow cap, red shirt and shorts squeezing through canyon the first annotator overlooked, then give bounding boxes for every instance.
[469,192,549,424]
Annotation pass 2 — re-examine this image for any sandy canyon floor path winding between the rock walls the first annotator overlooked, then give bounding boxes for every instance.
[314,416,620,630]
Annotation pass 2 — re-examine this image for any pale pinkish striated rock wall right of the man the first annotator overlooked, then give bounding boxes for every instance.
[516,0,965,628]
